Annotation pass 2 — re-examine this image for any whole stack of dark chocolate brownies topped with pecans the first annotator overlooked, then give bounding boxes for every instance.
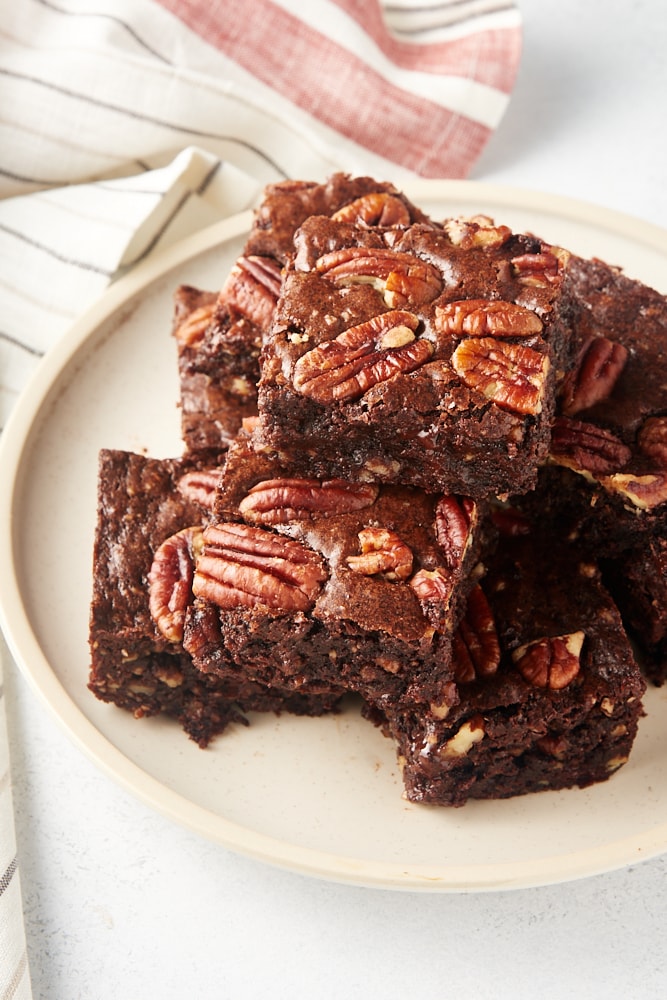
[89,174,667,806]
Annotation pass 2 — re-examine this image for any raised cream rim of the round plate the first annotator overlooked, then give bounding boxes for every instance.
[0,179,667,893]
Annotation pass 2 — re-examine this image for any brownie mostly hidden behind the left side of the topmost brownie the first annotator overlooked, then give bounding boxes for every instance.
[174,173,428,451]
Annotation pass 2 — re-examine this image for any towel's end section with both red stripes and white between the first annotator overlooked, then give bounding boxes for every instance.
[159,0,521,177]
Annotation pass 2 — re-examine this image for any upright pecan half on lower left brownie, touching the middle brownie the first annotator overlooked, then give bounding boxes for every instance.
[148,527,203,643]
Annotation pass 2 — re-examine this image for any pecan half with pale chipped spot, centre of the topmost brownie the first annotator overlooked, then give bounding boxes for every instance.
[293,310,433,403]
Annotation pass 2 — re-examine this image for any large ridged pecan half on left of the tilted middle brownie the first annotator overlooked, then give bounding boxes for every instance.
[192,523,327,611]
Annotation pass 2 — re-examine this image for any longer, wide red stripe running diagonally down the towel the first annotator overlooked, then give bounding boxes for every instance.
[153,0,490,178]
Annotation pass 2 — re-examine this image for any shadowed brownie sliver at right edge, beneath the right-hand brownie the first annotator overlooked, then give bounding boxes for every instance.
[603,537,667,686]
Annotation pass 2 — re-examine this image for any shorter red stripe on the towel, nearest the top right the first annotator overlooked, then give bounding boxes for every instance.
[331,0,522,94]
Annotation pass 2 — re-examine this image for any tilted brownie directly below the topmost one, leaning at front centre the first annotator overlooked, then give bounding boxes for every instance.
[184,438,488,712]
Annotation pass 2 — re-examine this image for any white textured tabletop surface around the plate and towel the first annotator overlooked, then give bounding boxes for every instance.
[5,0,667,1000]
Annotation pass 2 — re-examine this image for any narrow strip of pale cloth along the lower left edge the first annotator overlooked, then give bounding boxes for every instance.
[0,640,32,1000]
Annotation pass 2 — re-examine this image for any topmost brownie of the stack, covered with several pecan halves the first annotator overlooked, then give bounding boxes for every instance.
[259,216,570,499]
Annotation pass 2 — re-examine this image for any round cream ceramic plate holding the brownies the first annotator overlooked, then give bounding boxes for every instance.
[0,181,667,892]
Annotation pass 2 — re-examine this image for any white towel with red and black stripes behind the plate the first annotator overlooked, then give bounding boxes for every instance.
[0,0,521,427]
